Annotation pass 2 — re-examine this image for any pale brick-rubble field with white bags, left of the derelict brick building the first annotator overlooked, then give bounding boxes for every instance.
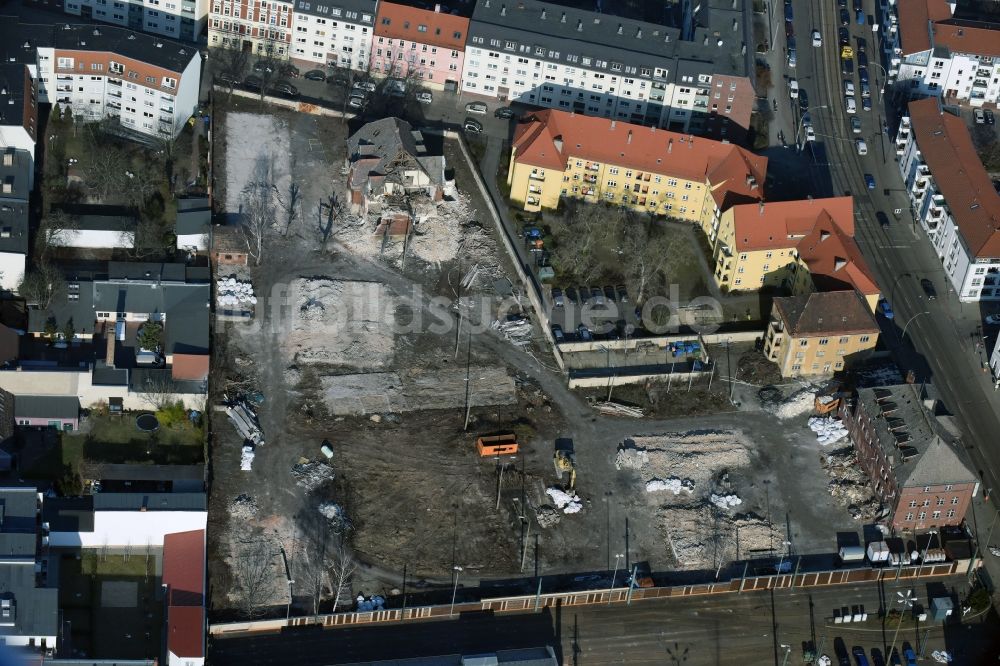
[615,430,782,569]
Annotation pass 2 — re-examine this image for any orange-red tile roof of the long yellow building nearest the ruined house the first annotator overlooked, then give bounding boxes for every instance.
[514,109,767,202]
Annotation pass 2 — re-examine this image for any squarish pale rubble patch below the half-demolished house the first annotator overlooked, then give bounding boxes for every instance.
[283,278,398,370]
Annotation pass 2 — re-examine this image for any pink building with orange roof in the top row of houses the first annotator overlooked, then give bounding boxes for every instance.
[371,0,469,91]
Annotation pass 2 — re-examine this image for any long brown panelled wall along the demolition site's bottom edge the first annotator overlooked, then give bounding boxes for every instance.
[208,560,976,638]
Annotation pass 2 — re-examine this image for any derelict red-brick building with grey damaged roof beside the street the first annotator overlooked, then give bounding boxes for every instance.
[840,384,979,533]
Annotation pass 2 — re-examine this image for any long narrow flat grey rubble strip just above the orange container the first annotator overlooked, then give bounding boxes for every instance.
[320,367,516,416]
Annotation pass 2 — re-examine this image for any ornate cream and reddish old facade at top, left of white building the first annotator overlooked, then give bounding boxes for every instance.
[208,0,294,55]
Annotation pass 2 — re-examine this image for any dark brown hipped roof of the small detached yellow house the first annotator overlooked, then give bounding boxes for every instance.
[774,289,878,338]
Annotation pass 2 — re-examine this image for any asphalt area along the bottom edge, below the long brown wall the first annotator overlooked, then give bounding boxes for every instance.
[209,577,996,666]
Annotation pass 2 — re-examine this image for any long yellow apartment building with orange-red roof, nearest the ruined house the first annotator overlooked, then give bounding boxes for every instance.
[507,109,767,228]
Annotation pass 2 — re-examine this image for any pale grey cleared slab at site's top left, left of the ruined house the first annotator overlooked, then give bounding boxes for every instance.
[225,113,292,214]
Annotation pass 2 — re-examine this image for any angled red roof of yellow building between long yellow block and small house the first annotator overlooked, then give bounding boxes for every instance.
[733,197,879,296]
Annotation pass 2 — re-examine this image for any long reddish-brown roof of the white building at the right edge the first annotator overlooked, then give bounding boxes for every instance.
[909,97,1000,257]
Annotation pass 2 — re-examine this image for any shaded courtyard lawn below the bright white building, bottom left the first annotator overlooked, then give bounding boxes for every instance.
[59,549,163,659]
